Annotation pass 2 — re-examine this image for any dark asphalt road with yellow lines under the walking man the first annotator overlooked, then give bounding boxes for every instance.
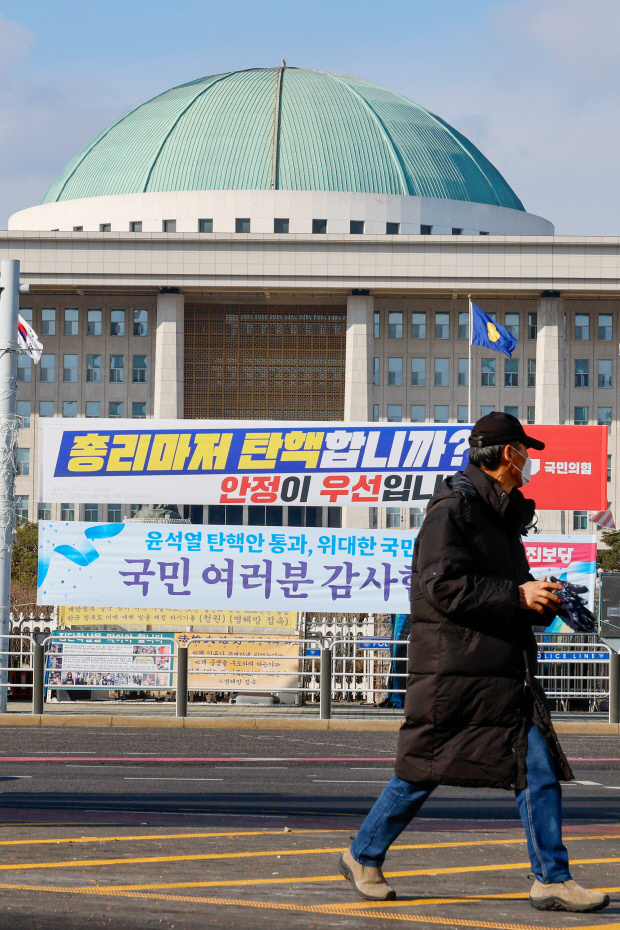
[0,727,620,930]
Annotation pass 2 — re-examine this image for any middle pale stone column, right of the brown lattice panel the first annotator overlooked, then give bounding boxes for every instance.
[342,294,375,529]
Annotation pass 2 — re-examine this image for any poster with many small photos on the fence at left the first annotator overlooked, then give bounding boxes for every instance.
[45,630,175,690]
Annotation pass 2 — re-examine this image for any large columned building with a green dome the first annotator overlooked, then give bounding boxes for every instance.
[0,62,620,532]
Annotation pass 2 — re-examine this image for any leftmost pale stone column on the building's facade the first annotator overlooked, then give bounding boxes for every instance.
[153,292,185,420]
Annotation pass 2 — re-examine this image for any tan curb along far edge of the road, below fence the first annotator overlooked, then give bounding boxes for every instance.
[0,713,620,736]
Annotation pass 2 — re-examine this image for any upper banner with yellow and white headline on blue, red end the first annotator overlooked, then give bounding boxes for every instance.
[39,418,607,510]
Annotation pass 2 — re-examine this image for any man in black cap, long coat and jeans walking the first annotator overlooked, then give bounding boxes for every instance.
[340,413,609,911]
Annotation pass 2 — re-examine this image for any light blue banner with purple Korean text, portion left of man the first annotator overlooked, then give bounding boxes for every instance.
[38,521,415,613]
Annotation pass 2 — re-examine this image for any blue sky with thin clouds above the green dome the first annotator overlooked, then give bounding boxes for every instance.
[0,0,620,235]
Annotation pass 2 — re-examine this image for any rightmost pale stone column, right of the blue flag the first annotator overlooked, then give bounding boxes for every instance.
[532,291,565,533]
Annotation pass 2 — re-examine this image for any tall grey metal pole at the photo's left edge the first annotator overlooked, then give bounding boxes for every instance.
[0,260,19,713]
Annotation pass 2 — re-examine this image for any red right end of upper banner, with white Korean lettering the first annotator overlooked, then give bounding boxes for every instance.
[522,424,608,510]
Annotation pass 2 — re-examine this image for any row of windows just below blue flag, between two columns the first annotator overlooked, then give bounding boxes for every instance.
[372,357,536,387]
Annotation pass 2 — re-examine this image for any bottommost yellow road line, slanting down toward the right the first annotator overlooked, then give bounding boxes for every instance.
[0,884,620,930]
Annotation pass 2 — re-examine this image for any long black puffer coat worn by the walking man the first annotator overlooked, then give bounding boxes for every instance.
[396,465,573,790]
